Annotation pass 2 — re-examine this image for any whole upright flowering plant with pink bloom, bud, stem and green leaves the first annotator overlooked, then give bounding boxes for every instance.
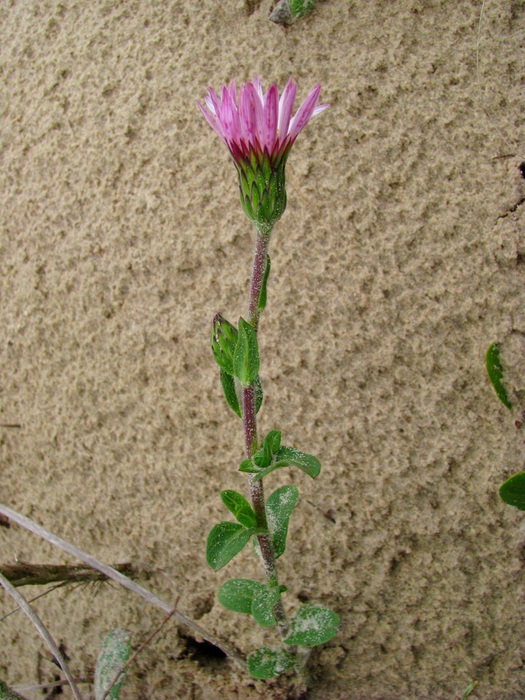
[197,77,339,679]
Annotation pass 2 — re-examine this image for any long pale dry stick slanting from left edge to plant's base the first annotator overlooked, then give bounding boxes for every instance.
[0,503,248,672]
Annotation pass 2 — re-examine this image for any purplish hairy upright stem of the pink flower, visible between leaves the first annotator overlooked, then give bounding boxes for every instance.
[242,231,288,637]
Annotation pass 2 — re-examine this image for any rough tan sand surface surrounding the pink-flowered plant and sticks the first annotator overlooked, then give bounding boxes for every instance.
[0,0,525,700]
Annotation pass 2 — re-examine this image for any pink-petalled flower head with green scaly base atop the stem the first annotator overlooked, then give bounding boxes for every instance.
[197,77,329,233]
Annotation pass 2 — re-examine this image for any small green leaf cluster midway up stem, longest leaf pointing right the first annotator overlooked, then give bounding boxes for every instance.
[239,430,321,481]
